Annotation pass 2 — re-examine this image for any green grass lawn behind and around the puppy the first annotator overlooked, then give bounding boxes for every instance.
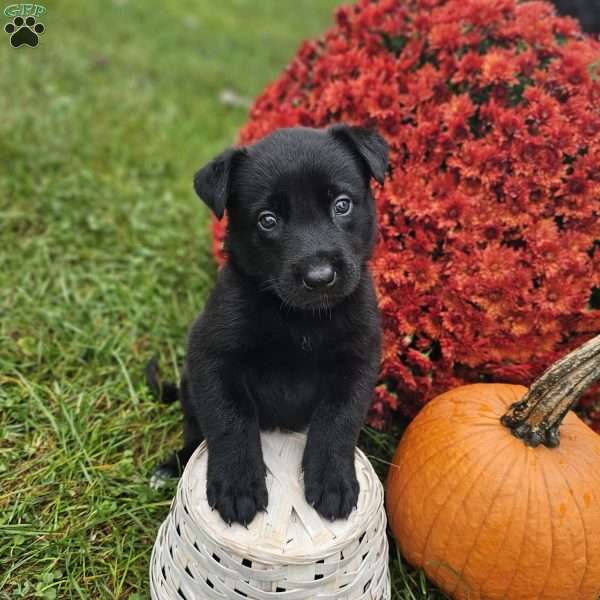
[0,0,441,600]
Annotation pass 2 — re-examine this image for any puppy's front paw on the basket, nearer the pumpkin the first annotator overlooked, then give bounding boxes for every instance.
[304,465,359,521]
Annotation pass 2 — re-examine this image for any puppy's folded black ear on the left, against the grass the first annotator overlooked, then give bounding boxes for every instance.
[194,148,246,220]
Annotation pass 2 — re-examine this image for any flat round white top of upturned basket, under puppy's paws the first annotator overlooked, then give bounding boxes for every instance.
[181,432,383,564]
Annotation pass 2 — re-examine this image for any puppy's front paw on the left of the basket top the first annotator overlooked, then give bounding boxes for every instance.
[206,463,269,525]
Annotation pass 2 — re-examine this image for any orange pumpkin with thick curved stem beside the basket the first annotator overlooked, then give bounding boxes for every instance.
[387,336,600,600]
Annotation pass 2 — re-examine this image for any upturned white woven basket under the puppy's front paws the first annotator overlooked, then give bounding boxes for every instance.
[150,432,390,600]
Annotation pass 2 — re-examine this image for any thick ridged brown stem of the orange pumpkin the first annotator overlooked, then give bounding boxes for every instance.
[501,335,600,448]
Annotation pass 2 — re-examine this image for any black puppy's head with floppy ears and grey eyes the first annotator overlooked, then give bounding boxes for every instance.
[195,125,388,309]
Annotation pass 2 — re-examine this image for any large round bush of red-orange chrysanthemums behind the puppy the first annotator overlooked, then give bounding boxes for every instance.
[214,0,600,426]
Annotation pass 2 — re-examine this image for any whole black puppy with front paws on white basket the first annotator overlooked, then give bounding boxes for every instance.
[150,125,388,524]
